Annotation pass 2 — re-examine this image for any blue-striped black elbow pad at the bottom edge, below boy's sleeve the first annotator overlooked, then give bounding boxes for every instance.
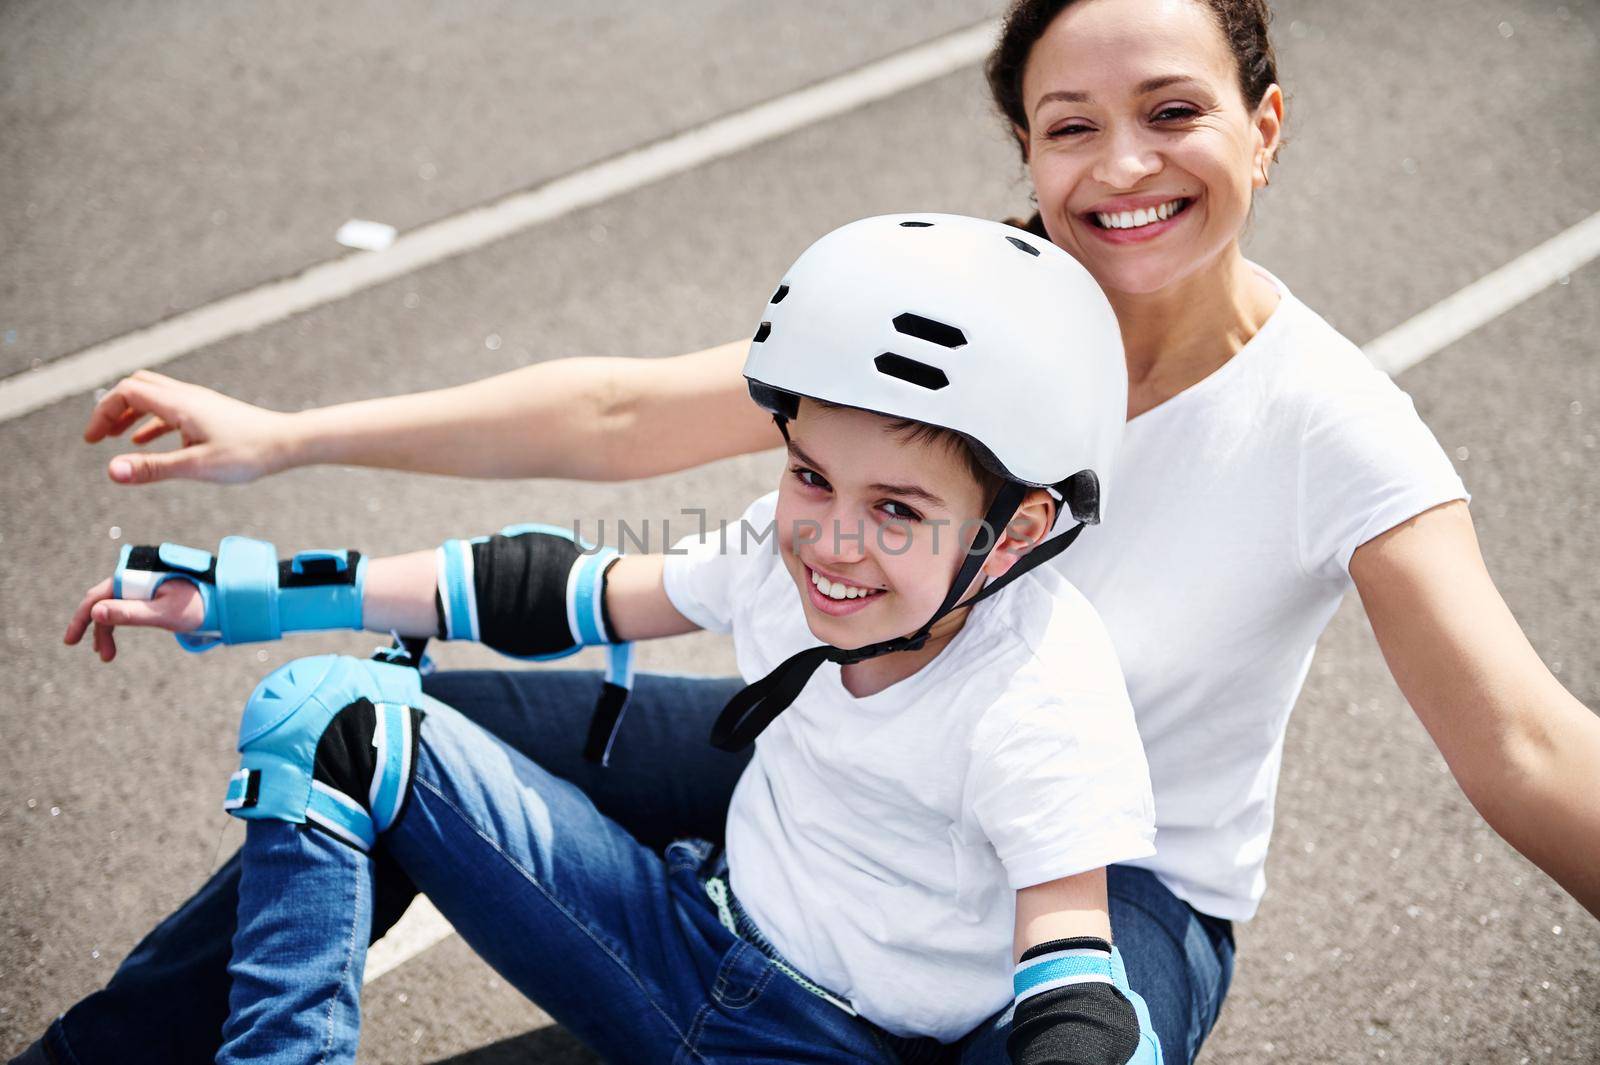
[1006,935,1162,1065]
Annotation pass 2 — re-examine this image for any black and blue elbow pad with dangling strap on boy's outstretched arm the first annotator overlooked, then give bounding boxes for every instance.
[435,525,634,764]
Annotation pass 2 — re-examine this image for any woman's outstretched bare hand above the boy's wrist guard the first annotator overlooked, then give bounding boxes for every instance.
[84,369,291,486]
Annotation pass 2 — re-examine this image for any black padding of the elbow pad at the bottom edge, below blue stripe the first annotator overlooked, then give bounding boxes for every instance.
[1005,983,1139,1065]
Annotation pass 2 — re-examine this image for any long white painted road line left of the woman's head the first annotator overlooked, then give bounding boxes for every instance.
[0,21,1000,422]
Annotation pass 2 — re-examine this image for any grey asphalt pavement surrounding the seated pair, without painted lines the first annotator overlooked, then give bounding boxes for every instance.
[0,0,1600,1065]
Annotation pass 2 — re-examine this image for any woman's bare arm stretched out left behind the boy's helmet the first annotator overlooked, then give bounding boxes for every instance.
[83,341,779,485]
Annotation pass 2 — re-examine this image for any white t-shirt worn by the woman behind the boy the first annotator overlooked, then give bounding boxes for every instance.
[1053,272,1467,919]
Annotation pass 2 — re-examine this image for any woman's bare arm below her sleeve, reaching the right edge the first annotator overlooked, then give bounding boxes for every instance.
[1350,501,1600,916]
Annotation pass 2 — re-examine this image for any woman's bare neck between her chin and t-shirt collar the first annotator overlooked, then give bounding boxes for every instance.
[1107,241,1278,419]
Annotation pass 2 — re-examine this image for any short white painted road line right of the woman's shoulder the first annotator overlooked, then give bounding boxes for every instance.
[1363,211,1600,374]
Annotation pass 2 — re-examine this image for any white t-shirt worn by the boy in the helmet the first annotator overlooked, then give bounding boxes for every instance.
[664,493,1154,1041]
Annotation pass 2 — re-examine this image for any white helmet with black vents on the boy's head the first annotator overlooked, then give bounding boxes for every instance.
[744,214,1128,523]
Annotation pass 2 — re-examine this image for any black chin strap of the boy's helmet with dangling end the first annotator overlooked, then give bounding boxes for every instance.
[710,481,1083,750]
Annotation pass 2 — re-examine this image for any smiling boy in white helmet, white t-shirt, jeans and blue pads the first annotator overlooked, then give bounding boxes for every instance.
[69,216,1160,1063]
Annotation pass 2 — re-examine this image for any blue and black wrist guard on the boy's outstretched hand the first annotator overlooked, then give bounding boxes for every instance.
[112,536,366,651]
